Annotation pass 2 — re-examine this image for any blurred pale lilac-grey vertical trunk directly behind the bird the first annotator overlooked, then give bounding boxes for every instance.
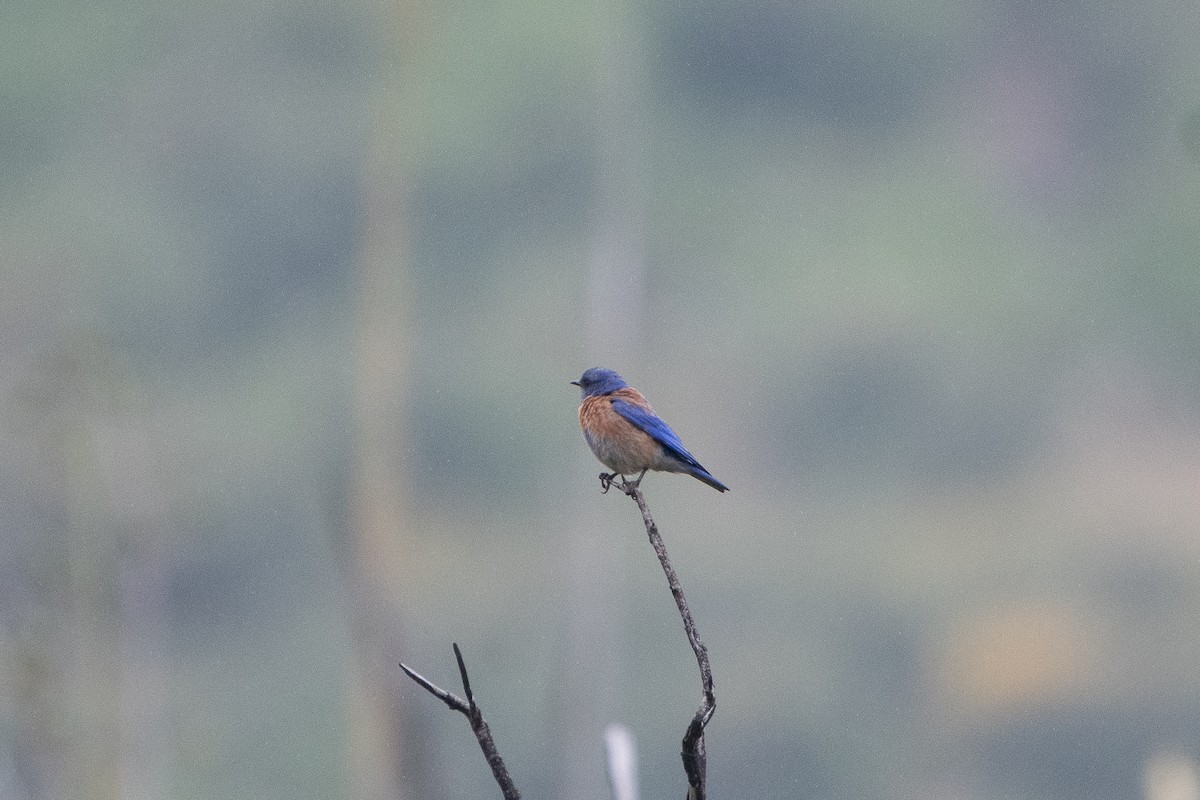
[557,0,648,800]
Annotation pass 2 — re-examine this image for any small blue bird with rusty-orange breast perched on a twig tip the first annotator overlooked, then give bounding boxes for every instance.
[571,367,730,492]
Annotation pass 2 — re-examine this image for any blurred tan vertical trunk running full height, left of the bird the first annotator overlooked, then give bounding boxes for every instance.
[347,2,424,800]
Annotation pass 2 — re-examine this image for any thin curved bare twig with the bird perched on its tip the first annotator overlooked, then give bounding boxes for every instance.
[614,475,716,800]
